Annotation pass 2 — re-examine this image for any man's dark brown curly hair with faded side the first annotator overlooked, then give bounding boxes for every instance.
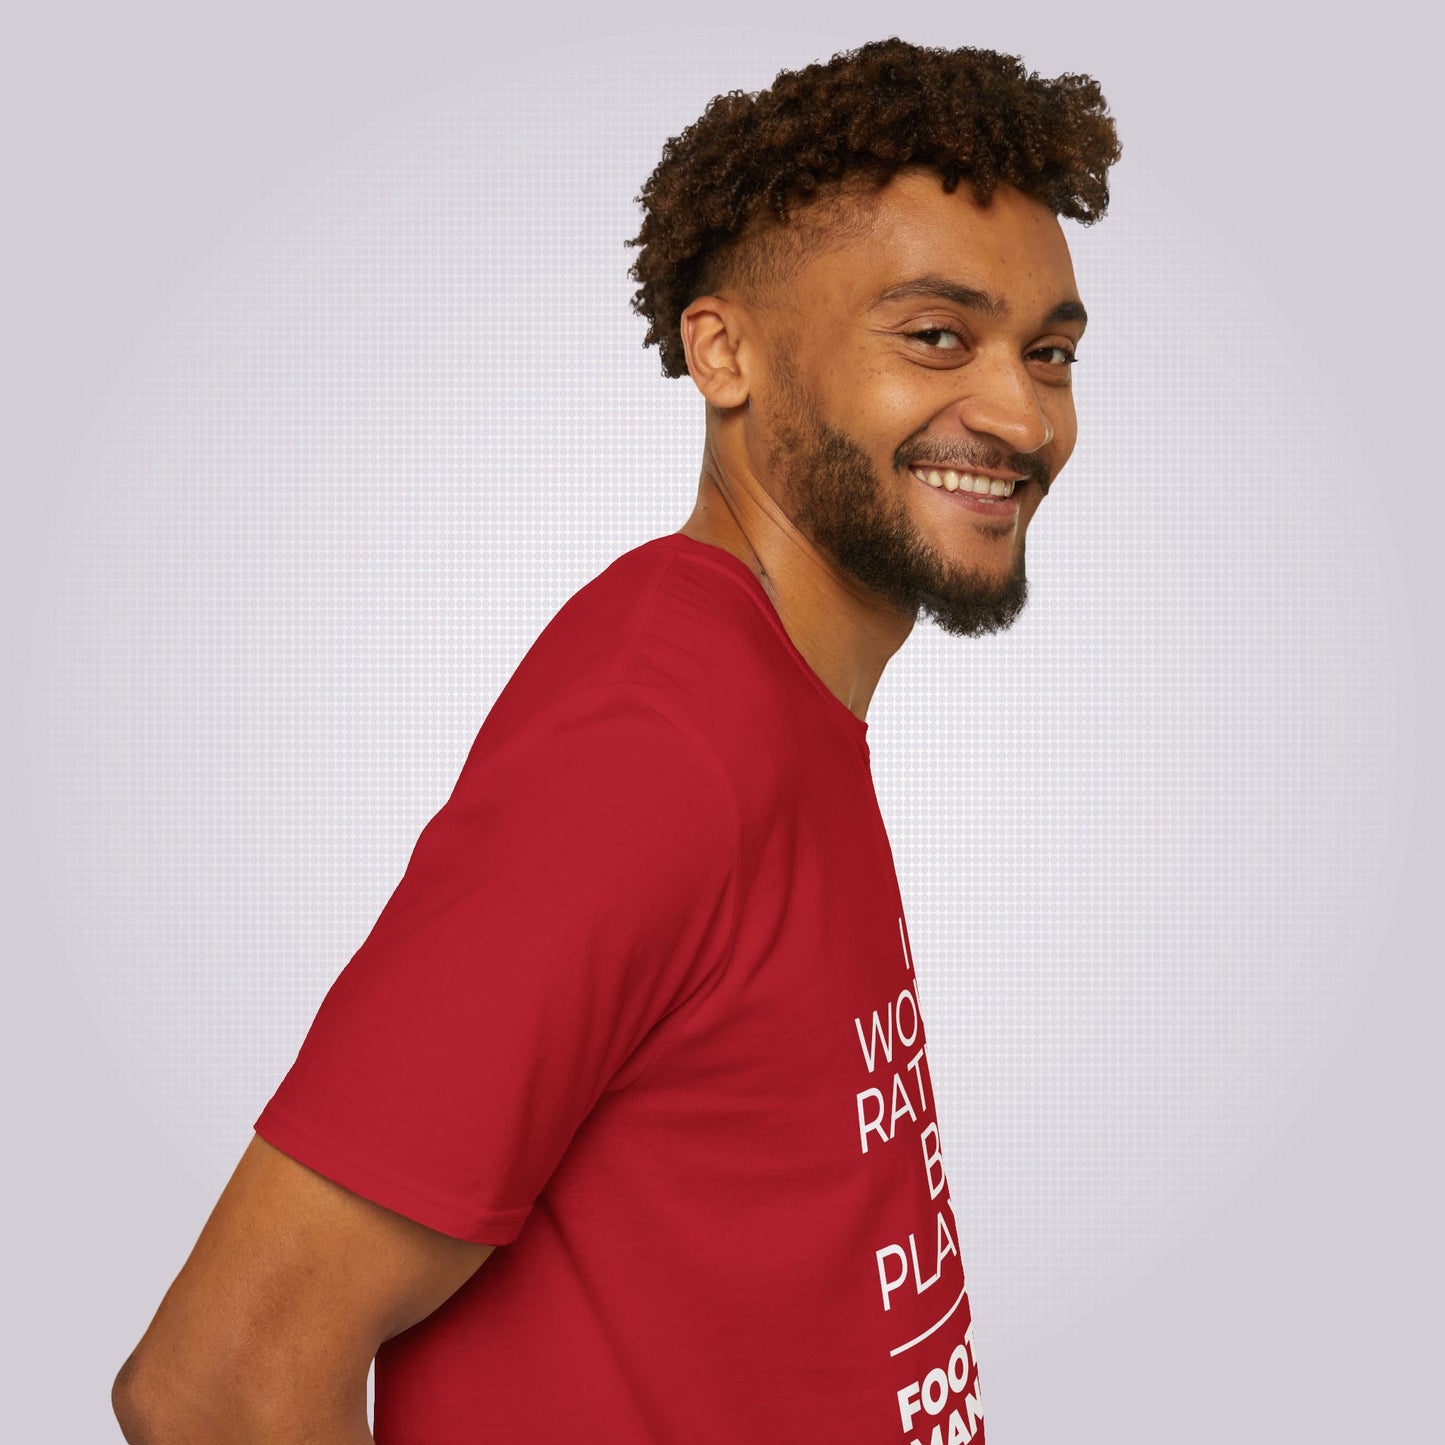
[626,36,1121,377]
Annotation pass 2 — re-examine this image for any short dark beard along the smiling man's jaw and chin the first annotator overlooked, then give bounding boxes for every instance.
[769,349,1029,637]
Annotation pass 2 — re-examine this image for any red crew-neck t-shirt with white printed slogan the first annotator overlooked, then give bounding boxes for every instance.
[256,533,984,1445]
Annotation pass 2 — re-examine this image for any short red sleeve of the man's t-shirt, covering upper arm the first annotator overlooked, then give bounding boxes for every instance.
[254,683,737,1244]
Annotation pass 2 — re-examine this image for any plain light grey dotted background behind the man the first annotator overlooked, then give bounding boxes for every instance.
[0,3,1445,1445]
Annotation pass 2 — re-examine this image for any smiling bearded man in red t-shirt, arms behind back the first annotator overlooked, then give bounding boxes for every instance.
[114,39,1120,1445]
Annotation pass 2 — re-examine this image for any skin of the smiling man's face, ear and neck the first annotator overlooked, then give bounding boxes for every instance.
[679,168,1084,718]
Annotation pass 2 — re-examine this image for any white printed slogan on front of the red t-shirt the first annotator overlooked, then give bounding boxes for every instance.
[853,918,984,1445]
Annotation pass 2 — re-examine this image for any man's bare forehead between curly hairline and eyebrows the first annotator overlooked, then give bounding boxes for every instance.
[799,171,1077,315]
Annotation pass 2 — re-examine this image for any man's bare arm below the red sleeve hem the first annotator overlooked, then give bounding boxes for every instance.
[116,1134,494,1439]
